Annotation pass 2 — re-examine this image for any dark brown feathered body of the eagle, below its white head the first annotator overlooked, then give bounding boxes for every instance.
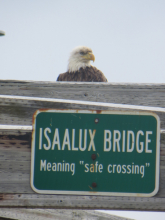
[57,66,107,82]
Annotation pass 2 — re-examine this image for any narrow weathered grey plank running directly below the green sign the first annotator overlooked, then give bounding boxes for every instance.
[0,194,165,211]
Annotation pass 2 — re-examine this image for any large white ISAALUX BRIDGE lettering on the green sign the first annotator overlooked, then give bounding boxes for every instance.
[39,127,153,153]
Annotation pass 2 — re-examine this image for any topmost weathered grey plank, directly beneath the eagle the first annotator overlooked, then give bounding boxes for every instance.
[0,80,165,107]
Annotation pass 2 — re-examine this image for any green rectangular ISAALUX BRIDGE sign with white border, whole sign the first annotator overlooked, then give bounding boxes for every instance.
[31,110,160,197]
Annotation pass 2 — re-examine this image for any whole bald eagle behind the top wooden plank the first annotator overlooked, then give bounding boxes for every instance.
[57,46,107,82]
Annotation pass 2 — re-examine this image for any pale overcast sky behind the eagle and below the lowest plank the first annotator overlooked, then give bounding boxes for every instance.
[0,0,165,220]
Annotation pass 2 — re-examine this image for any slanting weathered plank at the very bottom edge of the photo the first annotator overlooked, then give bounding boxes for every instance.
[0,208,131,220]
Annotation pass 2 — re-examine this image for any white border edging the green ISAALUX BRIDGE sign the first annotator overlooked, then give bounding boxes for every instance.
[30,109,160,197]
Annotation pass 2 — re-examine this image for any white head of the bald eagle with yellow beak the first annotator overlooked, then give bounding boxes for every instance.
[68,46,95,72]
